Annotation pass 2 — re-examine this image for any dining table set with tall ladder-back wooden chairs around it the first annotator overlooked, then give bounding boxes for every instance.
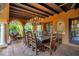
[26,32,57,55]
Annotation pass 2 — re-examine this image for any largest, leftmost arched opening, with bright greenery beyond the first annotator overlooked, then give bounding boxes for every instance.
[9,21,23,40]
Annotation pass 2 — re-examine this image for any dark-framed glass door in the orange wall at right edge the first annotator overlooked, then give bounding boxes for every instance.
[69,18,79,45]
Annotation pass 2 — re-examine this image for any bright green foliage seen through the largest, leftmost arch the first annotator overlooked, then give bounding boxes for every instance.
[9,22,23,36]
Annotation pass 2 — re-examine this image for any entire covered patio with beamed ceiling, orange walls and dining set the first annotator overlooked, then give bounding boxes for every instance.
[0,3,79,56]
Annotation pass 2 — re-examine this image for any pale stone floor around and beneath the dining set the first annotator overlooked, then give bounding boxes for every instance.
[0,41,79,56]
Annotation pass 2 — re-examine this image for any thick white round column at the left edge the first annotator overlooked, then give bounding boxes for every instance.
[0,23,7,48]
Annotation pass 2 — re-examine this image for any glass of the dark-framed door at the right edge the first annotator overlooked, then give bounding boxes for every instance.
[71,19,79,44]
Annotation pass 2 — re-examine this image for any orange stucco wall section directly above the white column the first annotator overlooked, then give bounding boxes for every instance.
[0,3,9,23]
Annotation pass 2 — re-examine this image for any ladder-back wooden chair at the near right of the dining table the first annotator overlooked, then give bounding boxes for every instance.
[43,33,57,55]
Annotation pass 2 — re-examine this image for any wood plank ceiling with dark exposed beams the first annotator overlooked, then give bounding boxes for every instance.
[10,3,79,19]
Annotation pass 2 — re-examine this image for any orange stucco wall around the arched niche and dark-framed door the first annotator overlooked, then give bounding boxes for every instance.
[43,8,79,47]
